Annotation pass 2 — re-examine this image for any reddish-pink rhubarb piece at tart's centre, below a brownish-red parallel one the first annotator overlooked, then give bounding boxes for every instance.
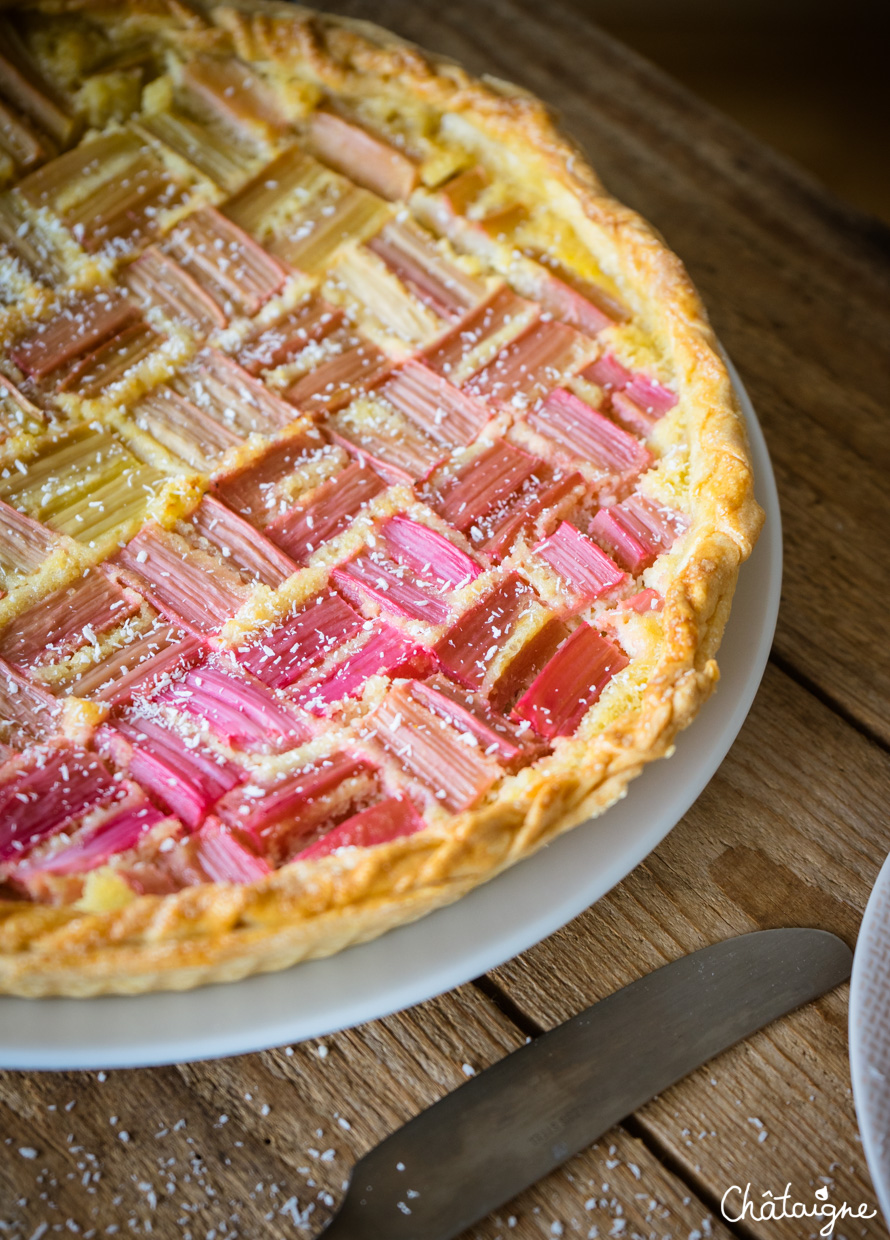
[265,461,384,564]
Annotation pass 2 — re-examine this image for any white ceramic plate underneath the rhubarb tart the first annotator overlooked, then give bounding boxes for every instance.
[0,362,782,1070]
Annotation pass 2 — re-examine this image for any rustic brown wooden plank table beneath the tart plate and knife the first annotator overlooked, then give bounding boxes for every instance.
[0,0,890,1240]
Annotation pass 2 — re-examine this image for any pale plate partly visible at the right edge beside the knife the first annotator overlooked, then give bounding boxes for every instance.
[850,858,890,1220]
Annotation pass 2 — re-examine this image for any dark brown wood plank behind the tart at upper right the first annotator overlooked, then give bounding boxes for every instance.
[330,0,890,742]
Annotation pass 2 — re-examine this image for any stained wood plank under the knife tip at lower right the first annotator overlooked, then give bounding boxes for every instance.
[492,668,890,1240]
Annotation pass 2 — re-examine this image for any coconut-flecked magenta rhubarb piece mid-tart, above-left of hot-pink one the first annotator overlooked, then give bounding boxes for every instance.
[233,590,364,689]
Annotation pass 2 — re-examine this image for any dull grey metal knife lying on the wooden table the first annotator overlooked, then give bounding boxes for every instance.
[320,929,853,1240]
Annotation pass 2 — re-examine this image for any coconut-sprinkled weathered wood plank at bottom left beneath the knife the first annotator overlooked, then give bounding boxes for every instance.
[0,986,729,1240]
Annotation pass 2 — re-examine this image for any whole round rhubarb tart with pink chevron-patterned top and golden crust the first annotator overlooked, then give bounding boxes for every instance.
[0,0,761,996]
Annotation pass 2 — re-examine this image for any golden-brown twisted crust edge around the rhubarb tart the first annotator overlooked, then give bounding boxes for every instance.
[0,0,762,997]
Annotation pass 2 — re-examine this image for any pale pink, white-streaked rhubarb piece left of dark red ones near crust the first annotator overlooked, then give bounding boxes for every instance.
[367,686,501,812]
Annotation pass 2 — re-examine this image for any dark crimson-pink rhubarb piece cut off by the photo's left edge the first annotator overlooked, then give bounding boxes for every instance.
[0,744,119,864]
